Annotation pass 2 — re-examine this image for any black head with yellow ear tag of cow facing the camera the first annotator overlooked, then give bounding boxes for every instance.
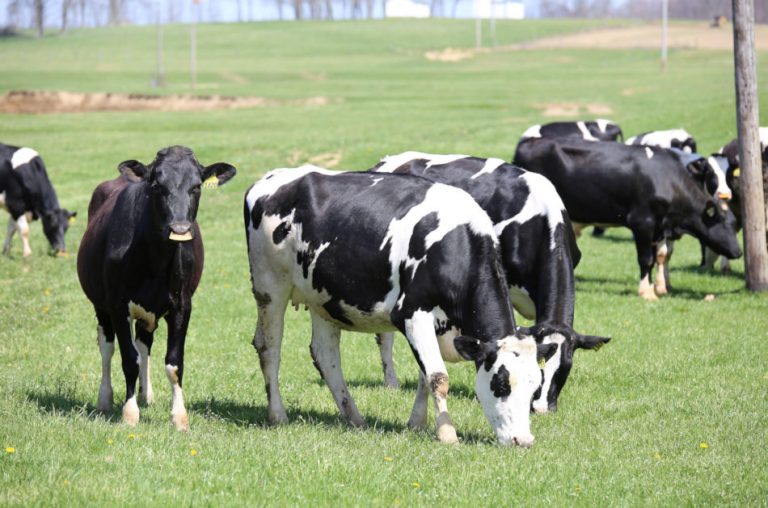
[119,146,236,242]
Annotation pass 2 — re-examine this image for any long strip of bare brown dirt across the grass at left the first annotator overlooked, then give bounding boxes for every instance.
[0,90,331,114]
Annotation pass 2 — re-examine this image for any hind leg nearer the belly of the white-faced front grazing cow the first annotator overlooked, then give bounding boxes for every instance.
[309,312,365,427]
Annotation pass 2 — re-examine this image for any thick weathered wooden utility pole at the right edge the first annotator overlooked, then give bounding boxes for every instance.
[732,0,768,291]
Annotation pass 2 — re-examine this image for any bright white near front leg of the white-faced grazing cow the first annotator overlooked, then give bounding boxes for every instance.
[405,311,459,443]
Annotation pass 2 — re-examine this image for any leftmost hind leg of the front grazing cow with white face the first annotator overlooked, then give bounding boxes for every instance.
[251,286,290,425]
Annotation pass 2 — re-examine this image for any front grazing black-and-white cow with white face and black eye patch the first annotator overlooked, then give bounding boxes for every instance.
[244,166,555,446]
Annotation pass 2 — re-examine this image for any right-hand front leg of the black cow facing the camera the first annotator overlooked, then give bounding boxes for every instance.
[165,308,192,430]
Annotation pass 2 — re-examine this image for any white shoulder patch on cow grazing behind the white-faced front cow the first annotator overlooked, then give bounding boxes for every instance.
[493,172,565,250]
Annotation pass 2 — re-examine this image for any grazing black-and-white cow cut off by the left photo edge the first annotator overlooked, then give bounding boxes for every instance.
[0,143,77,257]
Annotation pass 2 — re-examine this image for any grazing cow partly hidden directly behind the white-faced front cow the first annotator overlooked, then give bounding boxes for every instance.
[372,152,610,413]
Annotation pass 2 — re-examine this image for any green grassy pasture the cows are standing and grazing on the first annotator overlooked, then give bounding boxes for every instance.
[0,20,768,506]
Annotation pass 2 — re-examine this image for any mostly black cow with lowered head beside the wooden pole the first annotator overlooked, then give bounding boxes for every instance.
[514,139,741,300]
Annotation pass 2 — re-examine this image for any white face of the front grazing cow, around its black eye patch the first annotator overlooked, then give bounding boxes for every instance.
[475,336,541,446]
